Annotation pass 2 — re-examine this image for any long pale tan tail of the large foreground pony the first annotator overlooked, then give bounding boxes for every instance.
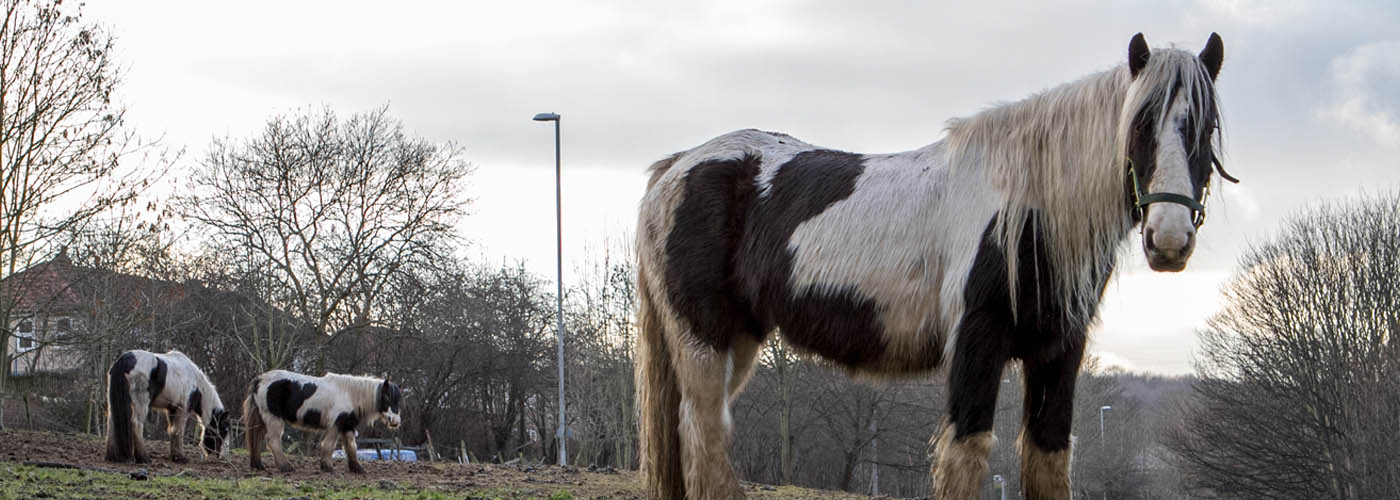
[636,265,686,499]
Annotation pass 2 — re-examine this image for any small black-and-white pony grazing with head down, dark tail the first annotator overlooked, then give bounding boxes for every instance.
[106,350,231,464]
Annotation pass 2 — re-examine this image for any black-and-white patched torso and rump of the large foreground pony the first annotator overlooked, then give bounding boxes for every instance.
[638,130,990,371]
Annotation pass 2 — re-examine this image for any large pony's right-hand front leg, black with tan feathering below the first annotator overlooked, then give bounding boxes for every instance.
[1016,336,1084,500]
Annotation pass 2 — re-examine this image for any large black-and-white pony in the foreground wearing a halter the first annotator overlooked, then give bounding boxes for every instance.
[637,34,1233,499]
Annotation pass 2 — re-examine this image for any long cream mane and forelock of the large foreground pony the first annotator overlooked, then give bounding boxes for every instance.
[946,49,1218,325]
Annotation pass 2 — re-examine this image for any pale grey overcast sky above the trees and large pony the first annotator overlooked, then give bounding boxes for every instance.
[88,0,1400,374]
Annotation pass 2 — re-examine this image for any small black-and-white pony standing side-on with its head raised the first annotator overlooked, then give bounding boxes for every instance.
[244,370,403,473]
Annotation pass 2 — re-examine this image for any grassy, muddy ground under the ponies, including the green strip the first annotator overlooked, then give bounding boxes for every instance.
[0,430,862,500]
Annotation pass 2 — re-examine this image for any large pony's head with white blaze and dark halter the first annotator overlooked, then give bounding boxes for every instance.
[1119,34,1238,272]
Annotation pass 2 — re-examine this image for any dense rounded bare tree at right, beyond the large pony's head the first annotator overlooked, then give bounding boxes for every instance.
[1170,193,1400,499]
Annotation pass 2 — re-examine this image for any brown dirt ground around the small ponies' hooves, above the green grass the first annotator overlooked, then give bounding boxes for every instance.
[0,430,861,499]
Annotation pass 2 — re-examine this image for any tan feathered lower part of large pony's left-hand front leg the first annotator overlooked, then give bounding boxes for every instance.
[932,423,995,500]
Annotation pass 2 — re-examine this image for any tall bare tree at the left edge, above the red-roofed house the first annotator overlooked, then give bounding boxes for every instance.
[0,0,162,425]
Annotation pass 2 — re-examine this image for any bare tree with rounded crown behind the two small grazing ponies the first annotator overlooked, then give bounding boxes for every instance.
[179,108,472,371]
